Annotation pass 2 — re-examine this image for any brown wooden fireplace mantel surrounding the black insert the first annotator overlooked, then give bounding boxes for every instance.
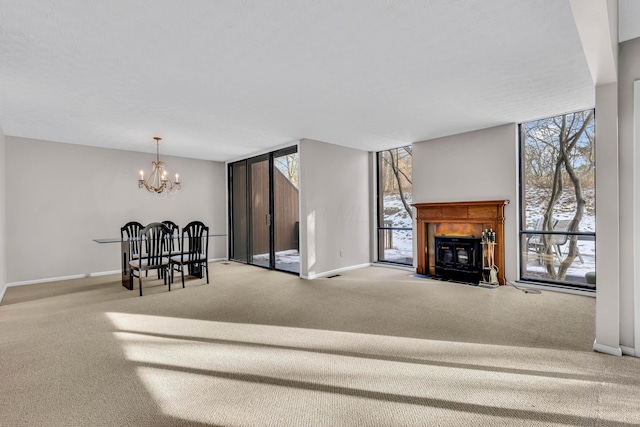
[413,200,509,285]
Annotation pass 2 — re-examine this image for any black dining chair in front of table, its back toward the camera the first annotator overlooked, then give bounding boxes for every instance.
[129,222,171,296]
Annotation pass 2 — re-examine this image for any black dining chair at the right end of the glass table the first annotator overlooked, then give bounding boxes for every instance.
[169,221,209,288]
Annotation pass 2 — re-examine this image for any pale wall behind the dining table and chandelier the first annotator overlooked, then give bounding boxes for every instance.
[6,136,226,284]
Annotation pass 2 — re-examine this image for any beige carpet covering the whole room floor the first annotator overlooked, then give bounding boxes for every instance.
[0,262,640,426]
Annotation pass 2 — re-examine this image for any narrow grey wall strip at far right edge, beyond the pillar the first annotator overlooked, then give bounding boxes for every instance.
[616,39,640,350]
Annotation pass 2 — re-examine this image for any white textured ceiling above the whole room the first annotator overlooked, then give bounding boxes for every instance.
[0,0,640,160]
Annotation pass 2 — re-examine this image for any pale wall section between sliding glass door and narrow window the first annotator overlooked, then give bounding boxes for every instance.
[300,139,371,279]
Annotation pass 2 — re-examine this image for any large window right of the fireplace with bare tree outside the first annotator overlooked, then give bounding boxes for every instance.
[520,110,596,289]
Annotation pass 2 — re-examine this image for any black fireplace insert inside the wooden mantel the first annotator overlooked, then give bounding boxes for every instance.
[435,236,482,283]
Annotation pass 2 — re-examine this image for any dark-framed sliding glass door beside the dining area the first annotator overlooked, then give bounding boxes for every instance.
[229,147,300,273]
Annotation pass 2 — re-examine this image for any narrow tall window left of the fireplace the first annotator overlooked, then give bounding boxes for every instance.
[378,149,413,265]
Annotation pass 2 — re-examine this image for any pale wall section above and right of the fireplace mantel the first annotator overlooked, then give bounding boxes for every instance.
[413,124,519,281]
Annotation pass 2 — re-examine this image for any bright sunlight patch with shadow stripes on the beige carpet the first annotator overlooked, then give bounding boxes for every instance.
[107,313,636,425]
